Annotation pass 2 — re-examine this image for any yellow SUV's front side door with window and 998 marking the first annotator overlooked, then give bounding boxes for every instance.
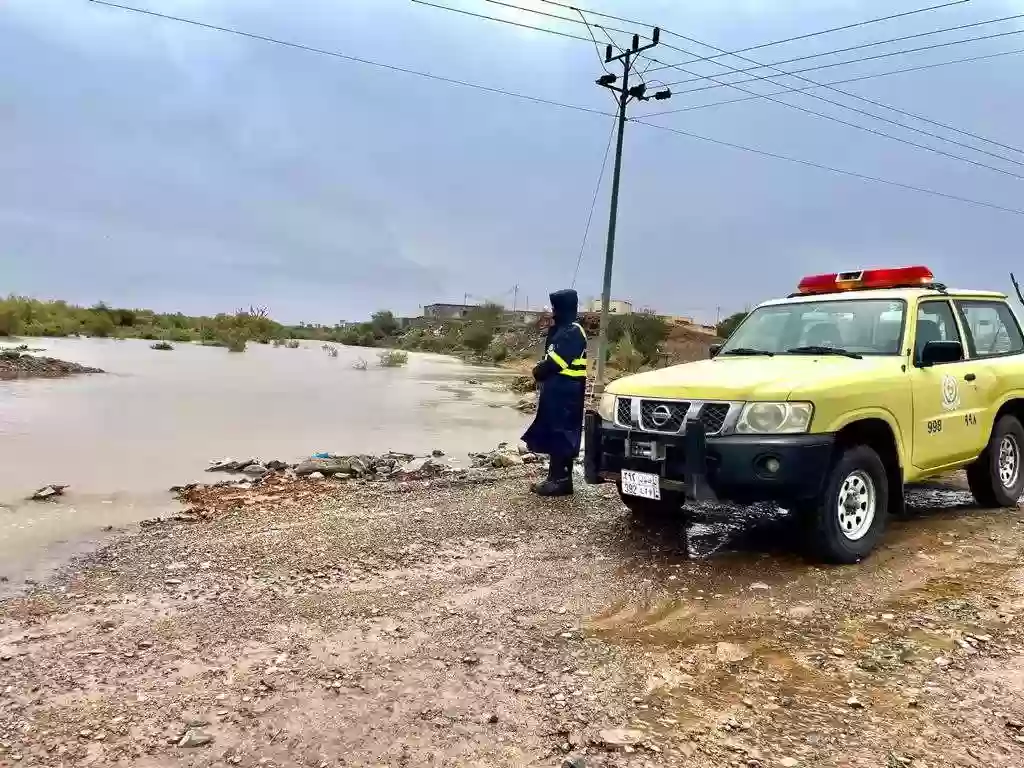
[910,299,982,470]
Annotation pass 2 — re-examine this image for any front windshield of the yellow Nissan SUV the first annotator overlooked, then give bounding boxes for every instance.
[719,299,906,356]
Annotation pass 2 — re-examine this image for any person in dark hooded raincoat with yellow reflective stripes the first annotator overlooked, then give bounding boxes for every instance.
[522,289,587,496]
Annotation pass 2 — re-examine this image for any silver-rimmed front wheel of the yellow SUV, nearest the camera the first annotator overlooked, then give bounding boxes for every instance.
[798,445,889,565]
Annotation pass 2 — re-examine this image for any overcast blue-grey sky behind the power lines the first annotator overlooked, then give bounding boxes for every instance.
[0,0,1024,323]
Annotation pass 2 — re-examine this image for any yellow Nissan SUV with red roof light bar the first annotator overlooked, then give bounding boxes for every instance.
[585,267,1024,563]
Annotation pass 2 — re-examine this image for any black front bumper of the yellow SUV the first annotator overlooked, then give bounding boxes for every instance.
[584,412,836,504]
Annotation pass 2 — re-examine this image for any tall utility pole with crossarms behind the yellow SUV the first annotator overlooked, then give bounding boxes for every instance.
[594,27,672,394]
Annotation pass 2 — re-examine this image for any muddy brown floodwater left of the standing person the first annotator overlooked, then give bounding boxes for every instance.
[0,339,526,578]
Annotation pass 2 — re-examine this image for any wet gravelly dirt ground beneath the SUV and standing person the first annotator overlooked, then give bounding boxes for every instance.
[0,468,1024,768]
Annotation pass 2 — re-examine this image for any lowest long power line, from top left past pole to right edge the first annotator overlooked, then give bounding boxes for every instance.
[89,0,1024,215]
